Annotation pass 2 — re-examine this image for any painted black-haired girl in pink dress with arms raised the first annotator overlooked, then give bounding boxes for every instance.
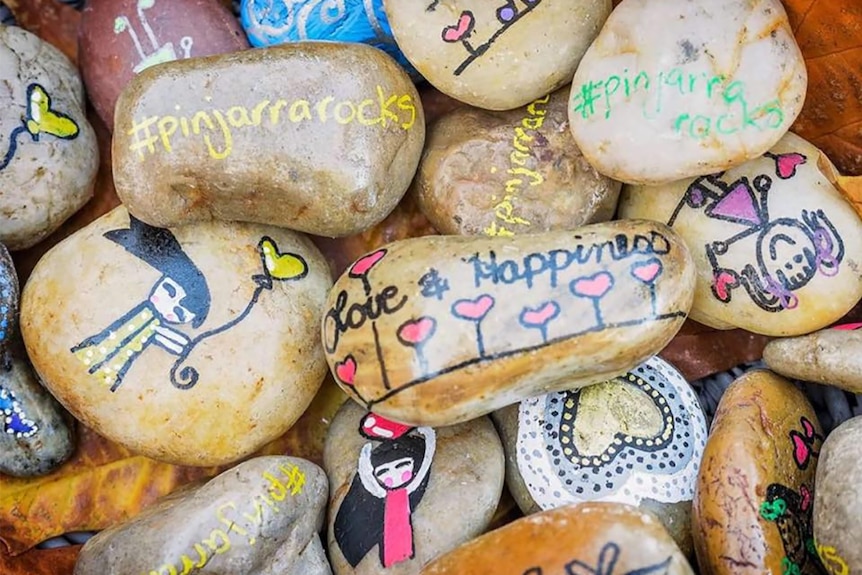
[334,427,436,568]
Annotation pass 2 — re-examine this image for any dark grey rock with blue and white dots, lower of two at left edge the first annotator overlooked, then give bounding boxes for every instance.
[0,341,75,477]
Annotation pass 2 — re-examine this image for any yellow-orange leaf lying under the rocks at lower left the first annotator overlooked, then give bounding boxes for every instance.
[0,378,346,556]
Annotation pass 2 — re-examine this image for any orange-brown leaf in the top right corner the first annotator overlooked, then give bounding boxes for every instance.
[784,0,862,176]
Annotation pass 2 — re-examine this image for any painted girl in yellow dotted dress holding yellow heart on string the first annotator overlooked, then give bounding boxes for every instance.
[71,214,308,391]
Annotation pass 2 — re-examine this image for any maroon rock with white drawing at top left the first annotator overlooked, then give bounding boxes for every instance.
[78,0,248,129]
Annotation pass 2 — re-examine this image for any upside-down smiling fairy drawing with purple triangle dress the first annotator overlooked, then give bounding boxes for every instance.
[668,154,844,312]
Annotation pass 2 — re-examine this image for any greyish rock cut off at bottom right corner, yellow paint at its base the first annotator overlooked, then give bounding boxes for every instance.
[814,417,862,575]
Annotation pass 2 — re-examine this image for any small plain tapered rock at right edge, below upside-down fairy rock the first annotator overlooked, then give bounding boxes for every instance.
[763,326,862,393]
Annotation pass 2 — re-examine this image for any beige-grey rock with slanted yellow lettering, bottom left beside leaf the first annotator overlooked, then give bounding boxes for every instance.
[75,456,331,575]
